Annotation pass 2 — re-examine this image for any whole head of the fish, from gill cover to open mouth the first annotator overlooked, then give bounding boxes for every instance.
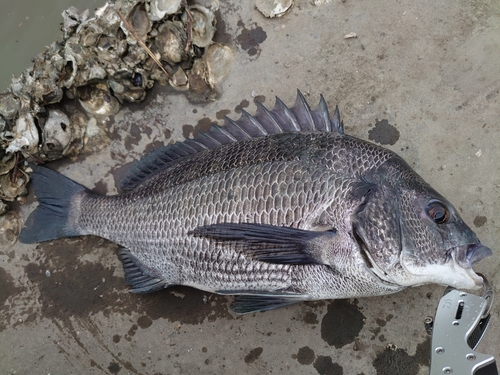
[354,159,492,289]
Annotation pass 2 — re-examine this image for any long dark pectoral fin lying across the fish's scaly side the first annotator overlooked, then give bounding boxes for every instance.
[189,223,336,265]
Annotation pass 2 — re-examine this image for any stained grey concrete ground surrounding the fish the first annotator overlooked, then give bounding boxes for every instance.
[0,0,500,375]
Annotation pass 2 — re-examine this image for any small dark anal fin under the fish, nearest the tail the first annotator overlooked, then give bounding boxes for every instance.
[118,247,168,294]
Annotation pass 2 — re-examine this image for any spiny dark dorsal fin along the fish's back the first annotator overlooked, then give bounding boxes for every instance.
[120,90,344,191]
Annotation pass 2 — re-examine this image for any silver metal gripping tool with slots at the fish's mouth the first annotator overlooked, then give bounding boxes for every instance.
[425,275,498,375]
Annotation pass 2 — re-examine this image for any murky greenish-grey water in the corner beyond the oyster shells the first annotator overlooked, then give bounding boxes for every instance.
[0,0,105,92]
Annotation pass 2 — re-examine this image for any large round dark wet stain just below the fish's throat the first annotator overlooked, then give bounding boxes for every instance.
[321,300,365,349]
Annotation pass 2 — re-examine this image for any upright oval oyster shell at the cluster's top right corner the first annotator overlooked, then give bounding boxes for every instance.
[182,5,216,48]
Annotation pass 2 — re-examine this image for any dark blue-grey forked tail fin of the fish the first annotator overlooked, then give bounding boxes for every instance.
[19,166,87,243]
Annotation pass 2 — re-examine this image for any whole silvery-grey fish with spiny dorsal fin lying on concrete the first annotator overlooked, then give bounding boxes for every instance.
[20,91,492,314]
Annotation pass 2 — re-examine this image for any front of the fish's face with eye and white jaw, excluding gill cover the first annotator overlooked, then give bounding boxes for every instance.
[392,187,492,289]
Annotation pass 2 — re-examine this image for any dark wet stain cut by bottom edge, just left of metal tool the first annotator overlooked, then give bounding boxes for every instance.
[373,345,419,375]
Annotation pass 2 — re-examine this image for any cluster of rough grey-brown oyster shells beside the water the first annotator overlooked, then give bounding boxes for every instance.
[0,0,234,229]
